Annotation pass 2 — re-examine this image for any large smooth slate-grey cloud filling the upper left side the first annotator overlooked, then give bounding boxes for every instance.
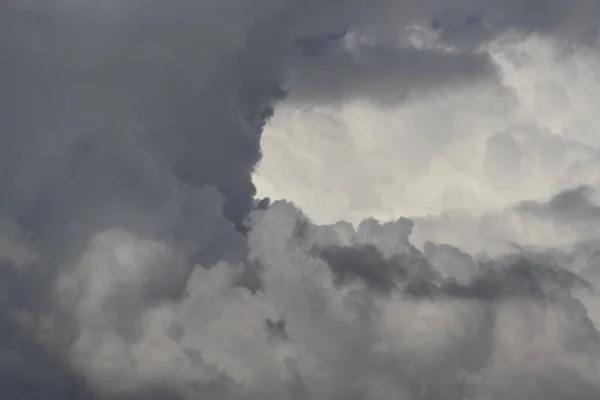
[0,0,292,399]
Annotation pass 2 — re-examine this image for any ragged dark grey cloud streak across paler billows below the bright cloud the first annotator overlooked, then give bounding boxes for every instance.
[314,225,591,303]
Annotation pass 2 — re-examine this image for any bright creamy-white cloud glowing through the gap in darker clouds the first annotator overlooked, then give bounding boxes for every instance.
[255,36,600,223]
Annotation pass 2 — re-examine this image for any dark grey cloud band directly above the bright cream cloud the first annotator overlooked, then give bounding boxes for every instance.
[286,0,600,103]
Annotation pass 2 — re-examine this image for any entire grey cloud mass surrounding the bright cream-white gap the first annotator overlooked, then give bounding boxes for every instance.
[0,0,600,400]
